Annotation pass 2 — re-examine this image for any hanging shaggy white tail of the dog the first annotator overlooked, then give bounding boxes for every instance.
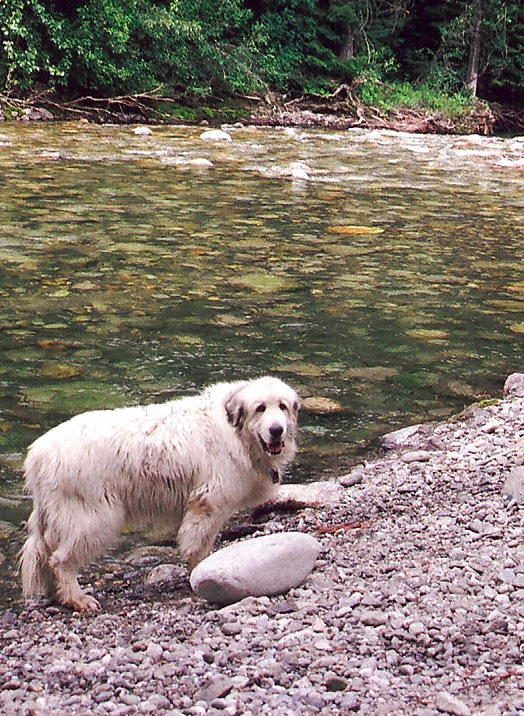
[19,509,53,598]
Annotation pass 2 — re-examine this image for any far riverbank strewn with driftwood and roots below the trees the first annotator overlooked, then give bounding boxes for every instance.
[0,85,524,136]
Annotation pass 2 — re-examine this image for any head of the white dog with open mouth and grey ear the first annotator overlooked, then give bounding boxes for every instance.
[226,376,300,467]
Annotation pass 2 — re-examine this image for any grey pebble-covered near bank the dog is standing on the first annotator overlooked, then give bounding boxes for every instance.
[0,376,524,716]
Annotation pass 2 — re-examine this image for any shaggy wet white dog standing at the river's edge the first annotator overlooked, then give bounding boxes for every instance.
[21,376,300,610]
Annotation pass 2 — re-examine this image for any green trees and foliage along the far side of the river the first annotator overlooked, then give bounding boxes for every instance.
[0,0,524,107]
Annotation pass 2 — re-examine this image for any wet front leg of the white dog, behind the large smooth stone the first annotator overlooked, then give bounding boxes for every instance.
[178,491,229,571]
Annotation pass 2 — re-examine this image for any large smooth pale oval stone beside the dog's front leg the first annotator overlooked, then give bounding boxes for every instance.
[189,532,320,604]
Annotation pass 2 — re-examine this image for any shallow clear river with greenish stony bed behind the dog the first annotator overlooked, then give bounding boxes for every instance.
[0,123,524,596]
